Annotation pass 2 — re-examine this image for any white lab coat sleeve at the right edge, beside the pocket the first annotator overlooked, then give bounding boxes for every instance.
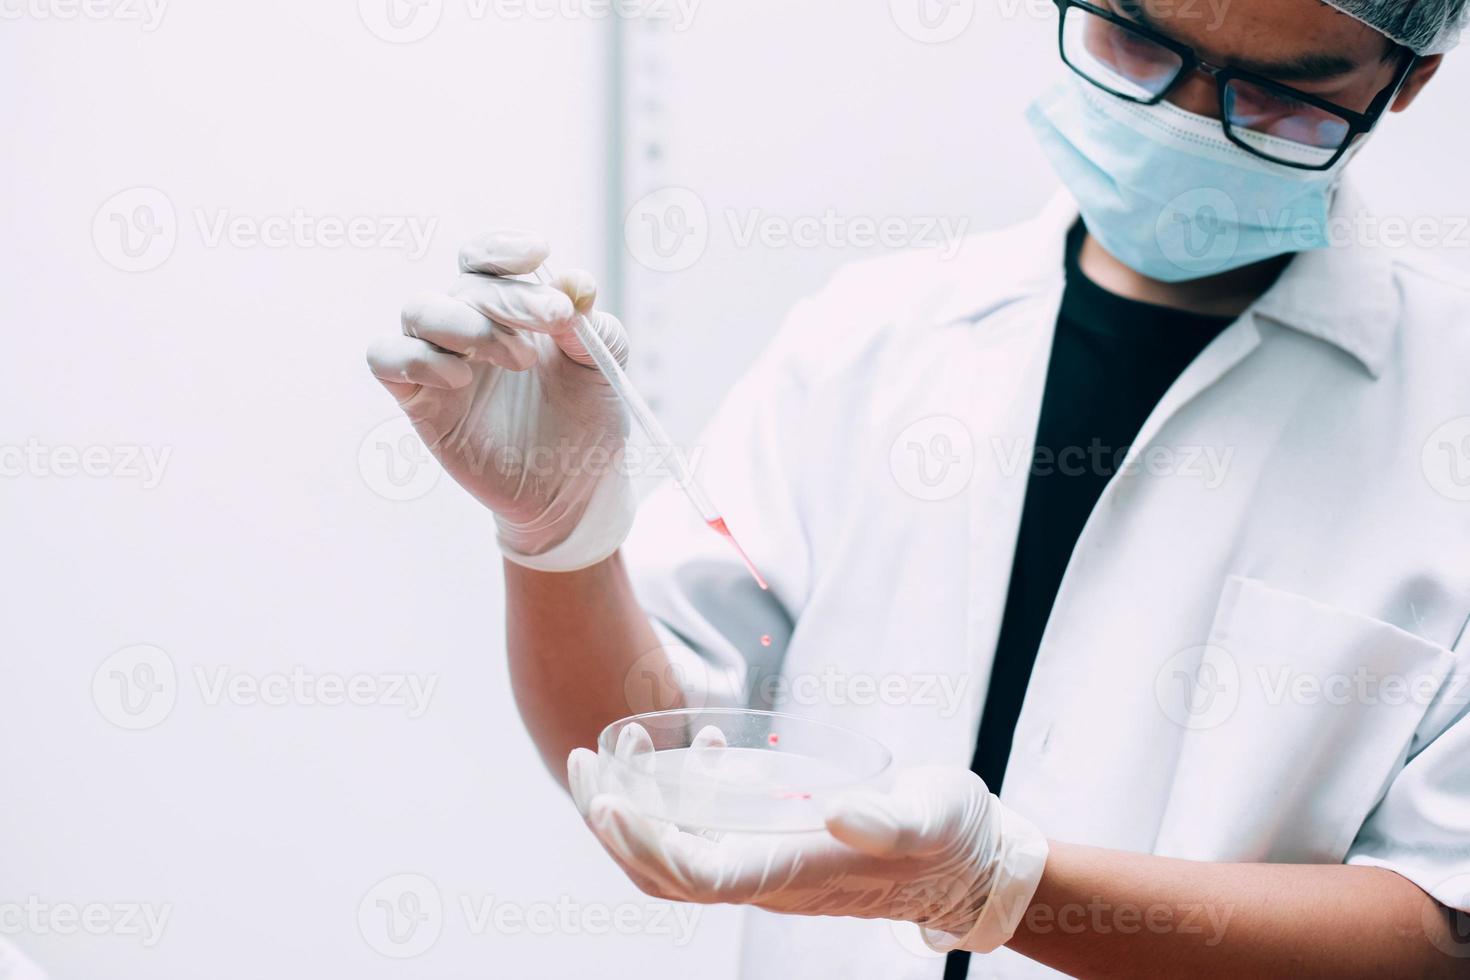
[1347,625,1470,912]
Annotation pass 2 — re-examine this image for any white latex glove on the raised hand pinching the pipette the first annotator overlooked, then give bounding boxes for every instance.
[368,231,635,572]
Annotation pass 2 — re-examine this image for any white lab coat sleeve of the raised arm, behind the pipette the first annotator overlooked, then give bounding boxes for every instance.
[623,285,835,710]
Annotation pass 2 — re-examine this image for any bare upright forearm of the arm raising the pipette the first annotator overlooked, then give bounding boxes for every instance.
[506,555,679,785]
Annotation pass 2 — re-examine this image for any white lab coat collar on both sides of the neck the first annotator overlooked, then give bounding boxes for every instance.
[938,184,1399,378]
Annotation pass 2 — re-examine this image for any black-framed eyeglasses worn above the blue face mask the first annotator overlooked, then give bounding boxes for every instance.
[1055,0,1417,170]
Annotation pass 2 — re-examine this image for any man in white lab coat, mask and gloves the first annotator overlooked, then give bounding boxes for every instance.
[369,0,1470,977]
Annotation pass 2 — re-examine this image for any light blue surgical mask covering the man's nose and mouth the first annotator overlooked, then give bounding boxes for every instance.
[1026,79,1352,282]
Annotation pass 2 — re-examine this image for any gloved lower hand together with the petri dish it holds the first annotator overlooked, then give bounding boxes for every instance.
[567,708,1048,952]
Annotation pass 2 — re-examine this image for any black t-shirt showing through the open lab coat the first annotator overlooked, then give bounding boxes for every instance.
[944,222,1230,980]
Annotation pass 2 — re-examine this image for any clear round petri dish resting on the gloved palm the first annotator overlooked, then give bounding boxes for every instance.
[597,708,892,833]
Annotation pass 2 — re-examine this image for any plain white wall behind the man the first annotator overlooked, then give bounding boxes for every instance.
[0,0,1470,980]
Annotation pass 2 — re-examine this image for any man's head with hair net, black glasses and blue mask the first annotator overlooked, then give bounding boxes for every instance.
[1029,0,1470,284]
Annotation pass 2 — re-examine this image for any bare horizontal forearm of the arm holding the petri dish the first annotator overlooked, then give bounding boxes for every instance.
[1008,843,1470,980]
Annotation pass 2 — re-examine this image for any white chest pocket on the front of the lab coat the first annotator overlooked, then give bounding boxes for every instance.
[1154,576,1454,862]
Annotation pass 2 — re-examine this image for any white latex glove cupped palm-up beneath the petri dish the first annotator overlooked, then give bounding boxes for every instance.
[567,726,1047,952]
